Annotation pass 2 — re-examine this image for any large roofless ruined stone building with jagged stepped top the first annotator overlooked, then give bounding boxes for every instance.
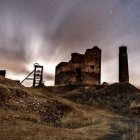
[55,46,101,85]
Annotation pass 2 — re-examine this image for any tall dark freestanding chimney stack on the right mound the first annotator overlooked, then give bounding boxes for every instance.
[119,46,129,83]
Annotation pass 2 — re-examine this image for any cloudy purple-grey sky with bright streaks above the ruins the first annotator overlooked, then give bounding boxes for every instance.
[0,0,140,86]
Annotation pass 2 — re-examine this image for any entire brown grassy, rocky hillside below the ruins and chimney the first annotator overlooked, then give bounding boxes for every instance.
[0,78,140,140]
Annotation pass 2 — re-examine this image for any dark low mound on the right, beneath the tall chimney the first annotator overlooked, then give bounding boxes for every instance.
[63,83,140,116]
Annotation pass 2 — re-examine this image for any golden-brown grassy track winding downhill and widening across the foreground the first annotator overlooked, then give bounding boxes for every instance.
[0,86,140,140]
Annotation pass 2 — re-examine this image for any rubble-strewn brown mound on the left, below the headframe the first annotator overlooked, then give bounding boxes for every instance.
[0,79,71,123]
